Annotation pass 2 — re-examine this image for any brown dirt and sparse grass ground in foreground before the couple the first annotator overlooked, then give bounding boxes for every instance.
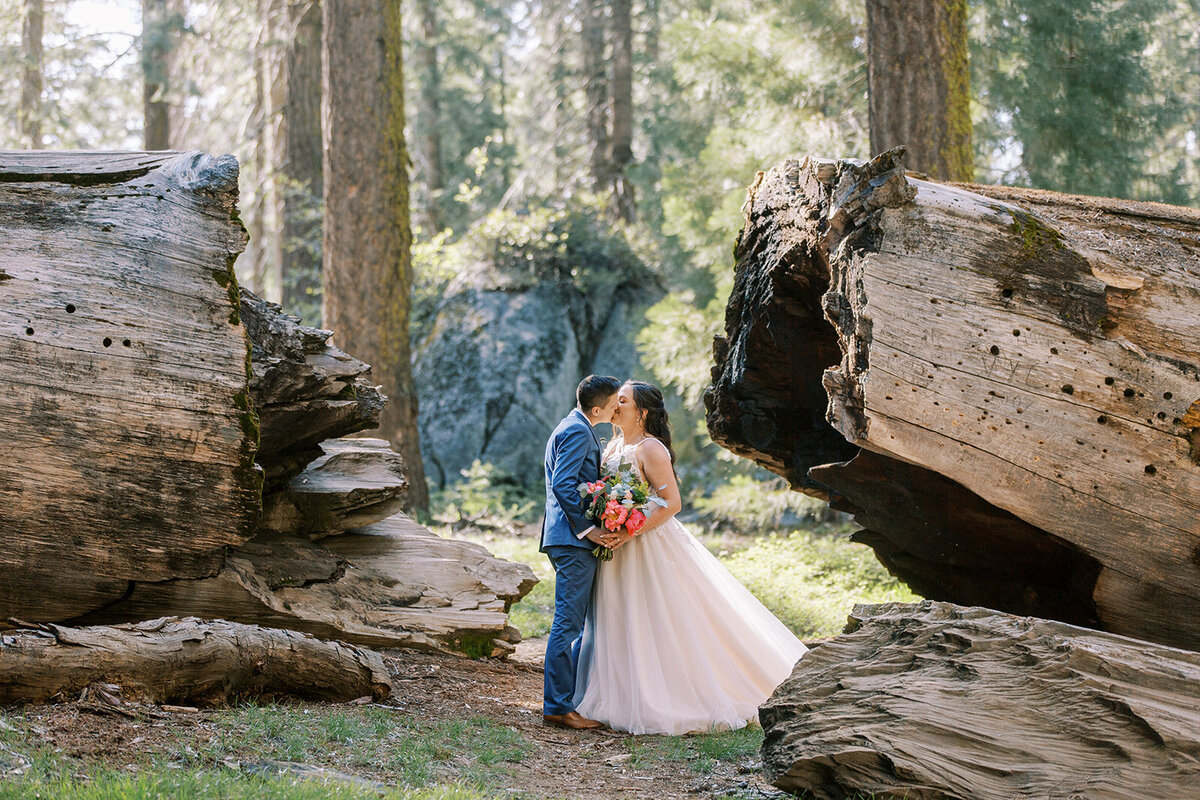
[0,639,788,800]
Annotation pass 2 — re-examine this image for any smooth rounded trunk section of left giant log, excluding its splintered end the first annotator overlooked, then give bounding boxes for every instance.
[0,151,260,619]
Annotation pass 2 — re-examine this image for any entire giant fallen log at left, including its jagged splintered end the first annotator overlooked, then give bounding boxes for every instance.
[0,152,535,655]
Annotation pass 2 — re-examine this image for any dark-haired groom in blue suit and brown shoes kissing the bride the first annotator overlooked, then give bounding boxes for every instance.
[541,375,620,730]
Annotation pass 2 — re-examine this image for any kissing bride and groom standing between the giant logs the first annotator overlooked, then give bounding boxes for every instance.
[541,375,806,735]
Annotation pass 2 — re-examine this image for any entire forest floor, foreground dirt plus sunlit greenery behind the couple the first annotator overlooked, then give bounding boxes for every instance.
[0,524,912,800]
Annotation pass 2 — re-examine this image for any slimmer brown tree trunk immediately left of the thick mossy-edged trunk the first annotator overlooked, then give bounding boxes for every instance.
[276,0,324,325]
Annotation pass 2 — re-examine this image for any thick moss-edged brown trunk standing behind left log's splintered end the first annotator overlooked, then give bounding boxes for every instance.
[323,0,428,510]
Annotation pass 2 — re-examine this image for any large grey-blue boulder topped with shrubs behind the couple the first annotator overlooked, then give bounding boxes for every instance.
[413,209,662,486]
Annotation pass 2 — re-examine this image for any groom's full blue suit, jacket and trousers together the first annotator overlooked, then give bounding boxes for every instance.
[541,409,600,714]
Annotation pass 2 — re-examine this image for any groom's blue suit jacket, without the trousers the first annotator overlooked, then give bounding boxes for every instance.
[541,409,600,552]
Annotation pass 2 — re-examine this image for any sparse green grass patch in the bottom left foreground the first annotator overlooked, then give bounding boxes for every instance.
[0,705,530,800]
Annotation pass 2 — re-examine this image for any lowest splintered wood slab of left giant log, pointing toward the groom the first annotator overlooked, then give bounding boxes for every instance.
[83,515,536,656]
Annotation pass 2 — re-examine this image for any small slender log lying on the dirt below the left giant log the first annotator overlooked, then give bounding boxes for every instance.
[0,618,391,705]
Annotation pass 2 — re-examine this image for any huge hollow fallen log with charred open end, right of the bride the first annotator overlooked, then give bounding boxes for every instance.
[706,151,1200,649]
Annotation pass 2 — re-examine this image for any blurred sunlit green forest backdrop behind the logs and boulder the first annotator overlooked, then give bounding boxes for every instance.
[0,0,1200,525]
